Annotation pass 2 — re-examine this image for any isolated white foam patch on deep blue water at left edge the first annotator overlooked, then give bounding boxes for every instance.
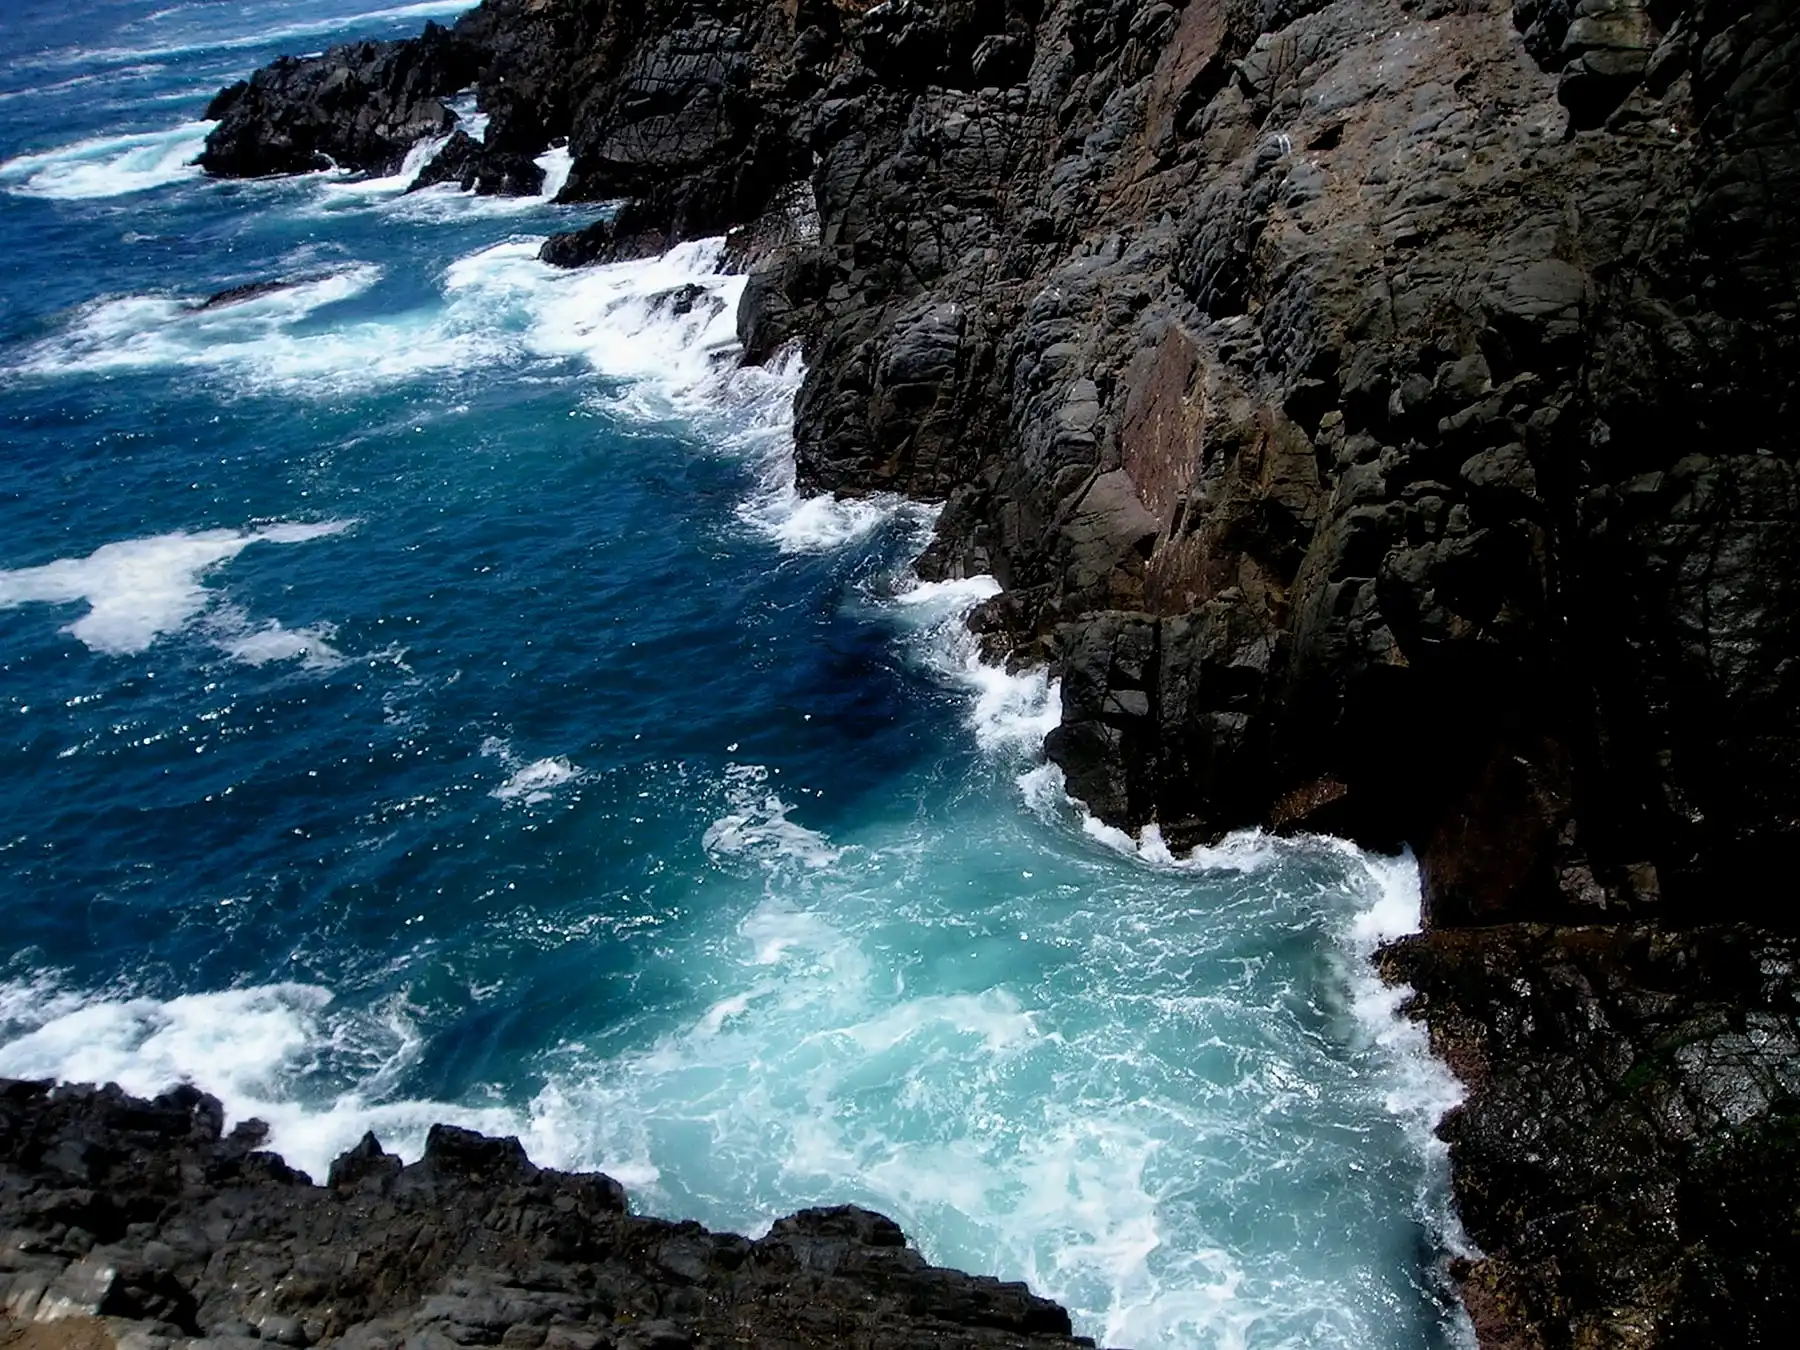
[0,520,351,655]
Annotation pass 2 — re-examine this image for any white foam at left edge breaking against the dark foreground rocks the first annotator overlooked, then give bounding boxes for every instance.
[0,977,518,1181]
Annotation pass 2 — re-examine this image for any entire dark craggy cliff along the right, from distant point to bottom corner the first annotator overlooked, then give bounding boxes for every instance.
[197,0,1800,1346]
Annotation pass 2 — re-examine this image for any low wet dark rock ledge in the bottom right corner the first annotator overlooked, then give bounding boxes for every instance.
[1382,925,1800,1350]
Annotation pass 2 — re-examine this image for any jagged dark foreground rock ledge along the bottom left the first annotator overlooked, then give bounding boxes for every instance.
[0,1080,1093,1350]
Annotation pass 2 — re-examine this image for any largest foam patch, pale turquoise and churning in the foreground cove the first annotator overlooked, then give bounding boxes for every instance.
[500,855,1296,1346]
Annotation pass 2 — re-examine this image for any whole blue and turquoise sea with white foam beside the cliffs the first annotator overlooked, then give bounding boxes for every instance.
[0,0,1467,1350]
